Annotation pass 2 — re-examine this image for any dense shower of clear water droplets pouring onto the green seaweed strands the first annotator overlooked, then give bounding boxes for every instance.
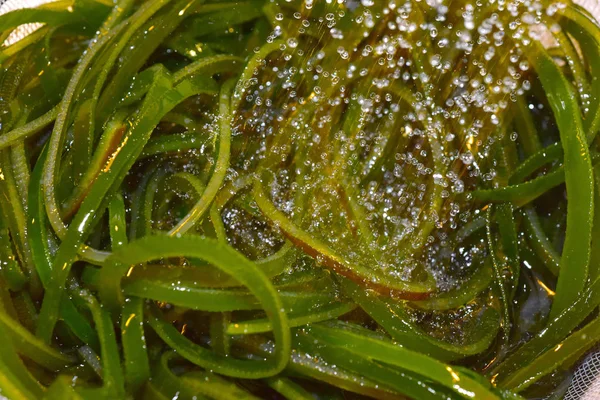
[225,0,564,287]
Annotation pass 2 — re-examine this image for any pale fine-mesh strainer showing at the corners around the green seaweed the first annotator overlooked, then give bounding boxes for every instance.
[0,0,600,400]
